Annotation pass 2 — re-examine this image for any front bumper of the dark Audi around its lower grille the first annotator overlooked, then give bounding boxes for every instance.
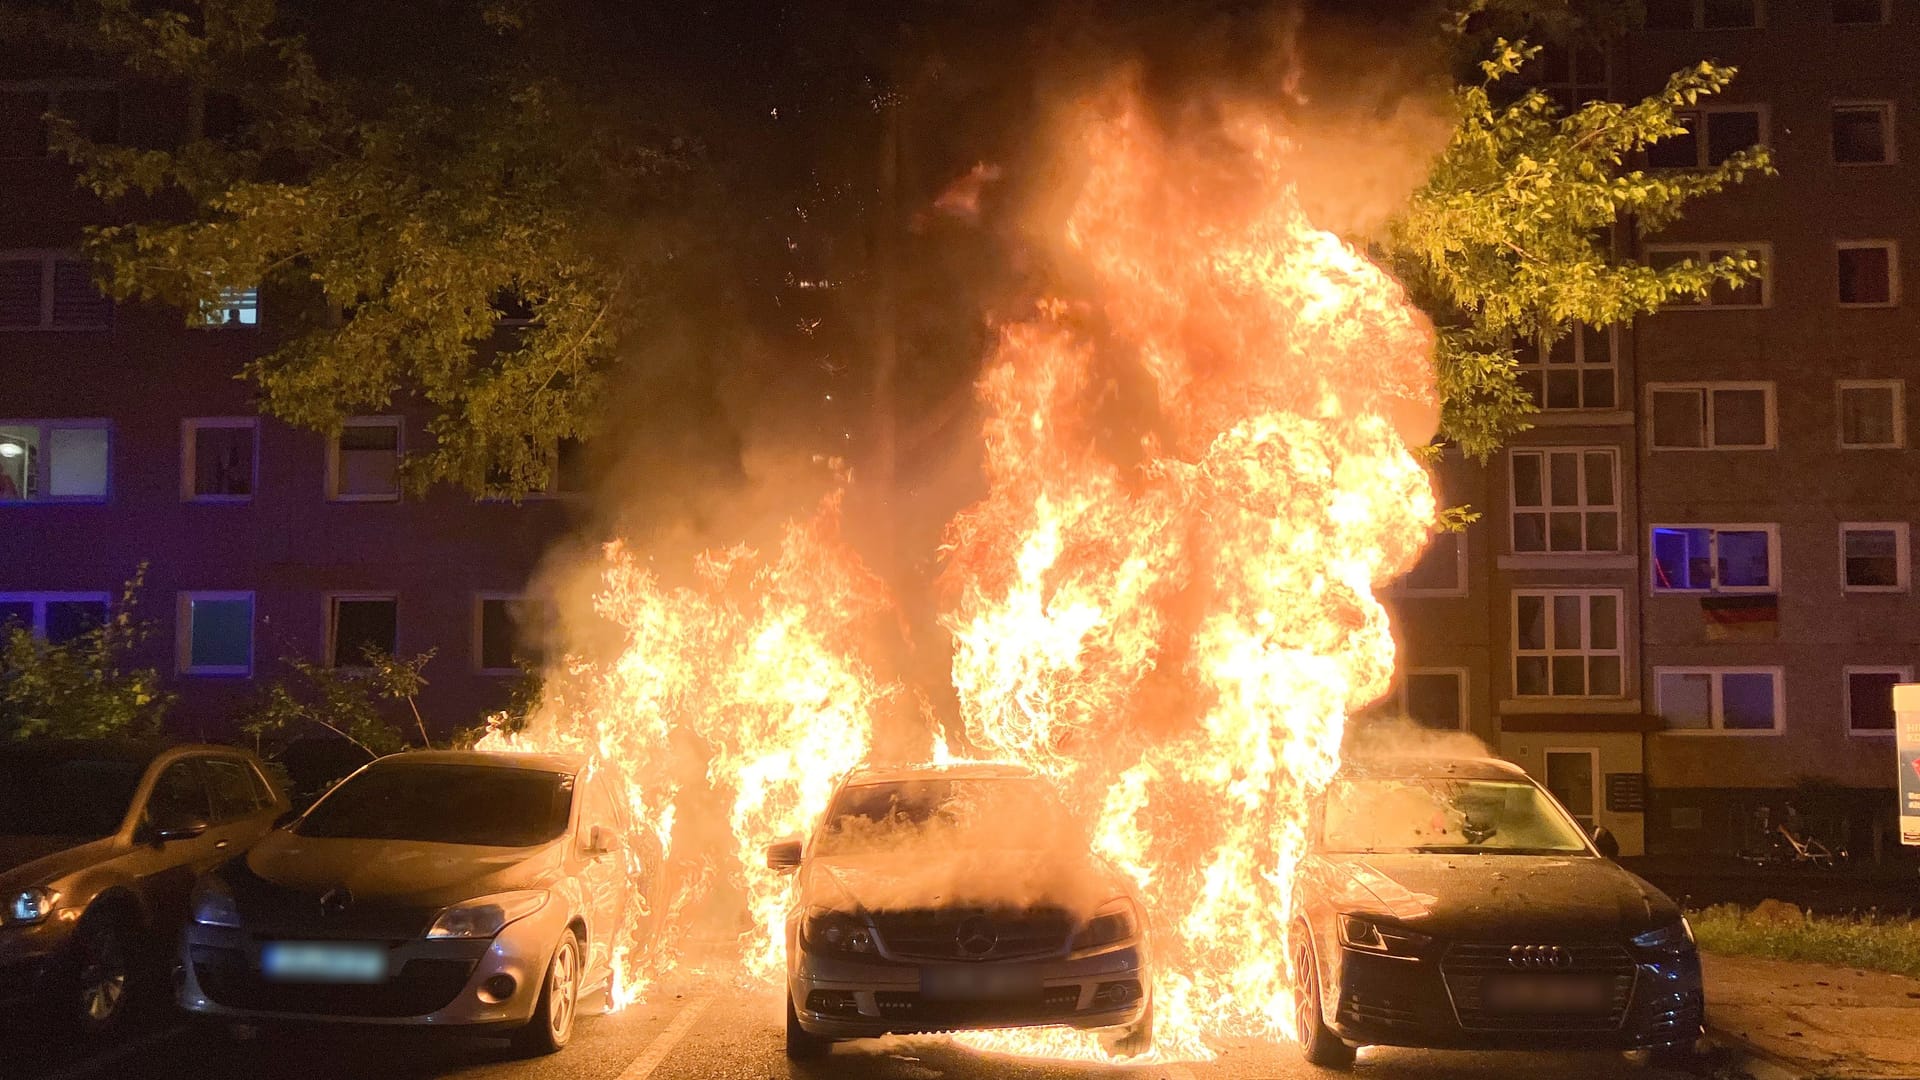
[1323,937,1705,1049]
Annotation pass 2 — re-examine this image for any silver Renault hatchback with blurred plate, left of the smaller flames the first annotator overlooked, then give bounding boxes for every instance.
[180,751,643,1053]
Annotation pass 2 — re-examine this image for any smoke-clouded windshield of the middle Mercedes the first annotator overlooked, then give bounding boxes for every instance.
[814,776,1077,855]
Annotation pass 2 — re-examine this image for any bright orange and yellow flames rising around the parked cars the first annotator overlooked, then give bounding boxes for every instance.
[488,75,1436,1059]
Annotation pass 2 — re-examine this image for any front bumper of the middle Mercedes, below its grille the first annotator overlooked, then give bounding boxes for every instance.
[787,945,1150,1040]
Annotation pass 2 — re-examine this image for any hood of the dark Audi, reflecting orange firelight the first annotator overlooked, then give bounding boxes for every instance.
[1329,855,1680,942]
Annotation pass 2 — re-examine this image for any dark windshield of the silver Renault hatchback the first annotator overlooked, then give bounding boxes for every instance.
[294,765,574,847]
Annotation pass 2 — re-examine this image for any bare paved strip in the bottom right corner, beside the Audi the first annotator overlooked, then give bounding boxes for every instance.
[1701,953,1920,1080]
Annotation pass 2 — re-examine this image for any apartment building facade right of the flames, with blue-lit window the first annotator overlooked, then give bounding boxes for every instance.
[1396,0,1920,853]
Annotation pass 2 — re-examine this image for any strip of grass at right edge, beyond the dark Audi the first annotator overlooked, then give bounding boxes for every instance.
[1688,903,1920,978]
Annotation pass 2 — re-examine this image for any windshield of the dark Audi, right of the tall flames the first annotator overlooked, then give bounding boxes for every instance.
[1321,776,1588,855]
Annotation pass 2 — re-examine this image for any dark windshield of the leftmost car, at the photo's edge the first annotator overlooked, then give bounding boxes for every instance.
[0,755,146,840]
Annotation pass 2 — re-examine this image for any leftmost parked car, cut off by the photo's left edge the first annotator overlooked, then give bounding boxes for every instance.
[0,740,288,1034]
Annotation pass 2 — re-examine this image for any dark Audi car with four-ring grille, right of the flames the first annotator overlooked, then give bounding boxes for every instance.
[1290,759,1703,1067]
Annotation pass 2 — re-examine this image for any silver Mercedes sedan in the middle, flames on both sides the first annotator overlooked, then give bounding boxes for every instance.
[766,765,1154,1059]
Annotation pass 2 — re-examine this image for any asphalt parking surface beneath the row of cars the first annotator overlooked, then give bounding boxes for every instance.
[0,960,1678,1080]
